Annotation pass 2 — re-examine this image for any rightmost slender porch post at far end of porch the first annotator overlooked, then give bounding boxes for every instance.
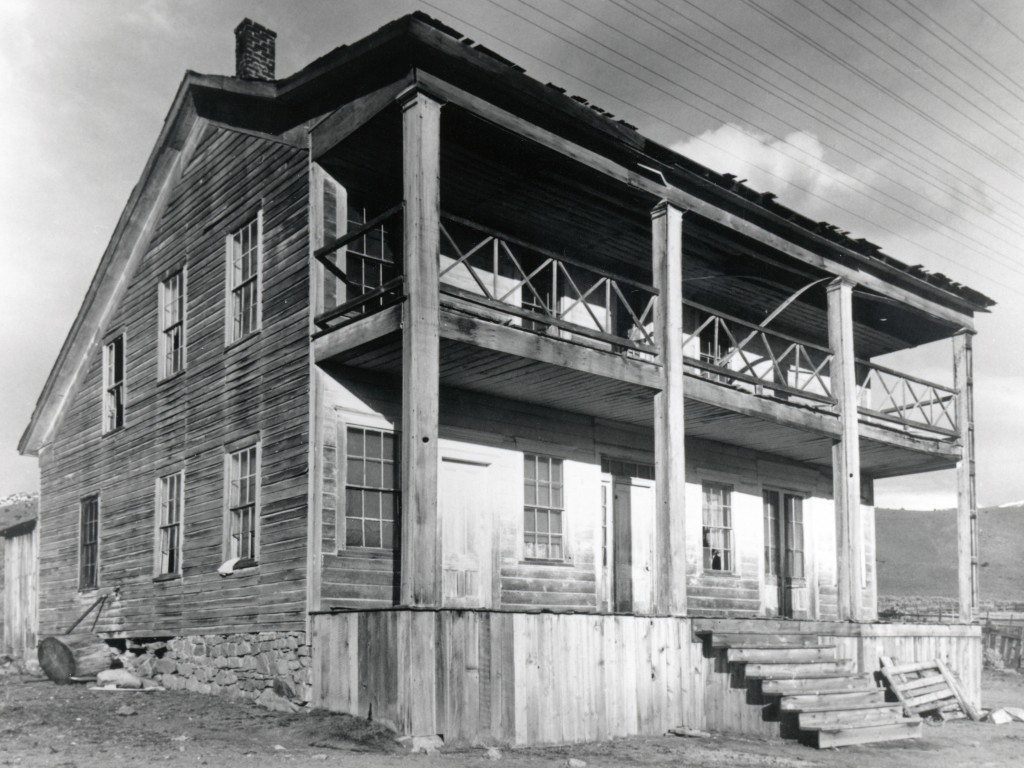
[953,331,978,624]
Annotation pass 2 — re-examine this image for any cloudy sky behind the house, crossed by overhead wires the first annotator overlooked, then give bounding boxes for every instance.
[0,0,1024,509]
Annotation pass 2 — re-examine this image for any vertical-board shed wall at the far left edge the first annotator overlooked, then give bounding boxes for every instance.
[0,527,39,658]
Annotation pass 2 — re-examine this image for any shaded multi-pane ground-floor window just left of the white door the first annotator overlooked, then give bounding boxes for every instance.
[345,427,399,549]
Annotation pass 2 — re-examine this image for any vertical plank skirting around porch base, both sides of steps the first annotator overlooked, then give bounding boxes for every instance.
[312,609,981,745]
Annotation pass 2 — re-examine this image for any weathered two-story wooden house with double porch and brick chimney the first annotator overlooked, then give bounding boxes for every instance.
[20,14,991,743]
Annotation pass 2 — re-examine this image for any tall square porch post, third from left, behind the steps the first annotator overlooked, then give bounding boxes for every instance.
[827,279,864,621]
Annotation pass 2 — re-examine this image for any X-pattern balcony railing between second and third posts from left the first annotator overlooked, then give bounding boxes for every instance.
[683,301,833,403]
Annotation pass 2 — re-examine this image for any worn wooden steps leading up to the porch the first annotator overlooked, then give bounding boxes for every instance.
[705,631,927,749]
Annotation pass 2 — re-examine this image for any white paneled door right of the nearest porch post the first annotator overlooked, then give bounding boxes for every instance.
[439,456,494,608]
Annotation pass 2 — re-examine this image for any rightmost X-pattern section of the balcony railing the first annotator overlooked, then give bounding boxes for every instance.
[857,360,958,436]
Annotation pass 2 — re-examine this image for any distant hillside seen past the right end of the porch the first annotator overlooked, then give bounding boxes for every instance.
[876,502,1024,602]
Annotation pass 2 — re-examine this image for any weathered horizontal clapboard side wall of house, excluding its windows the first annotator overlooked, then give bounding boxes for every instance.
[40,127,309,635]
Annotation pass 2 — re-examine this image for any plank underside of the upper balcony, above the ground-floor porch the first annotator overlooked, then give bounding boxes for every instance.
[319,315,956,477]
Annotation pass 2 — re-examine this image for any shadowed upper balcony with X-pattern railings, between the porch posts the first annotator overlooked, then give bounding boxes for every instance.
[312,83,963,477]
